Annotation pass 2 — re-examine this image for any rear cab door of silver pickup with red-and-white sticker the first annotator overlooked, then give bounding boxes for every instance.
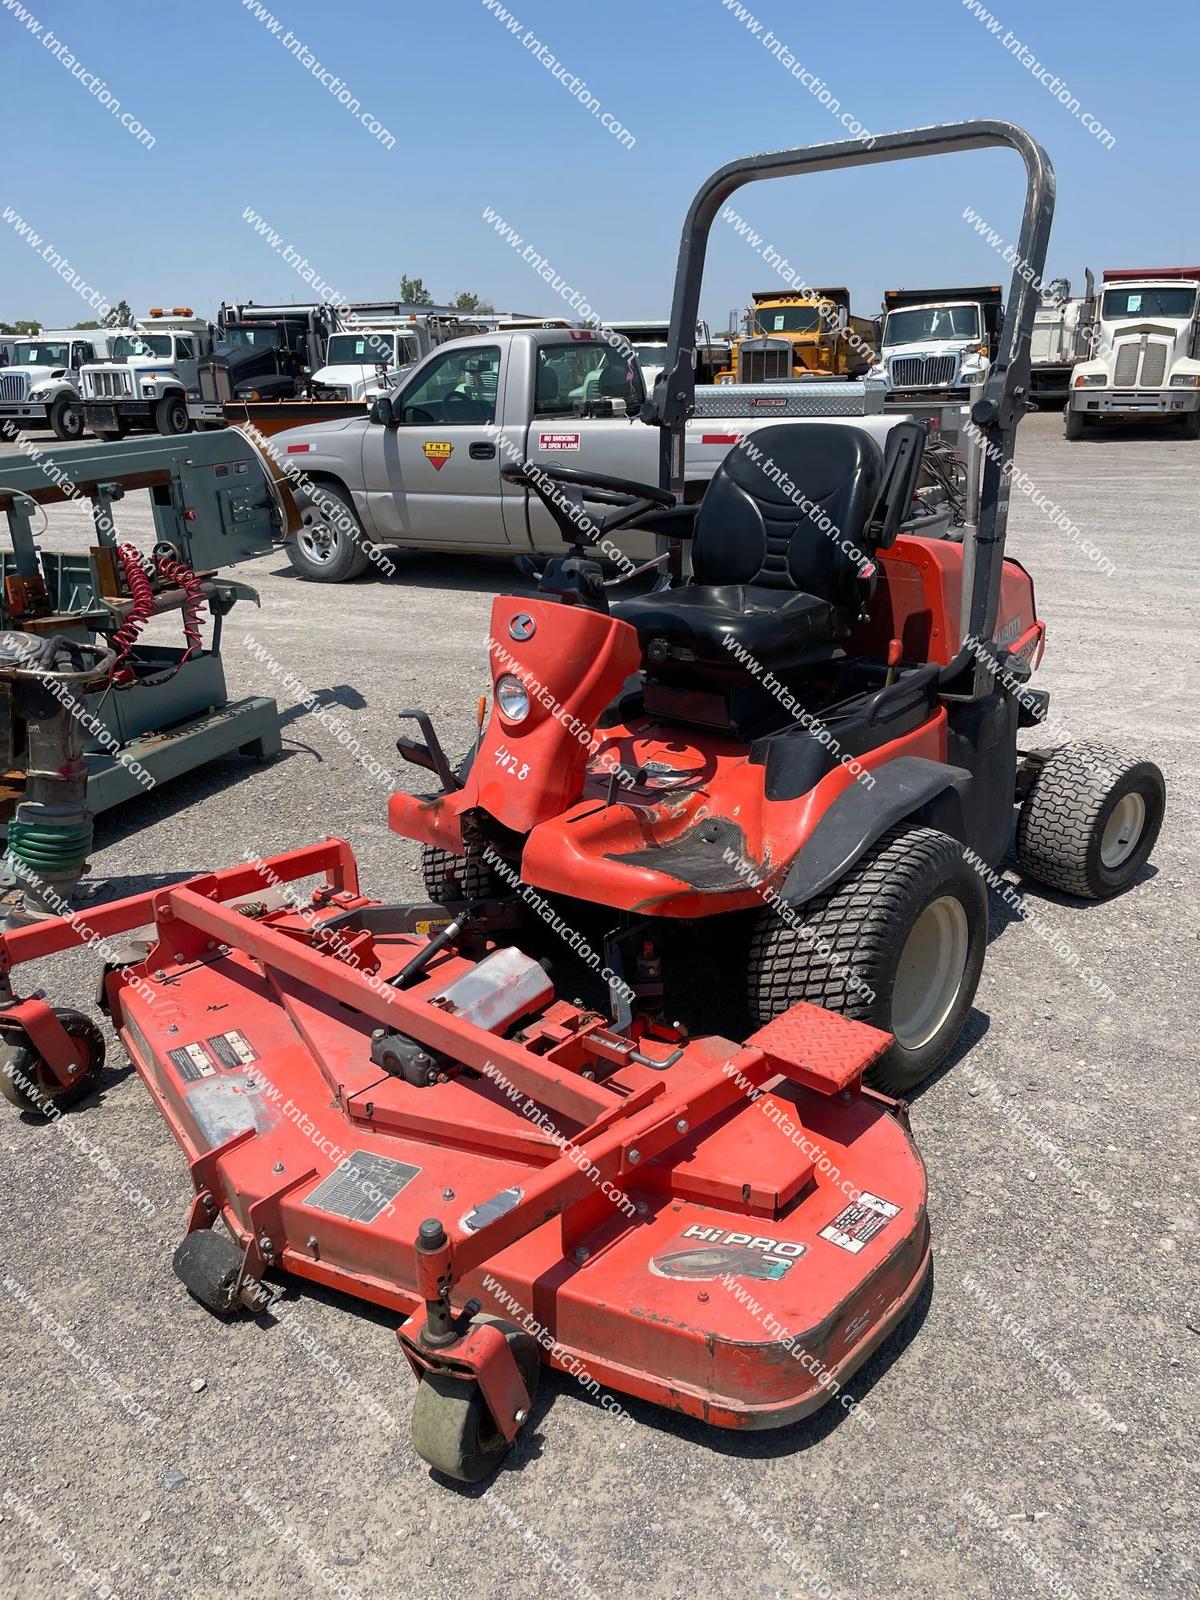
[525,338,659,560]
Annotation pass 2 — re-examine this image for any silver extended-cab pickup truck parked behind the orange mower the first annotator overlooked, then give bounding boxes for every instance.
[266,328,947,582]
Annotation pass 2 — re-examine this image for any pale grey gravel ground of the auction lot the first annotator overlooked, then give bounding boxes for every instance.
[0,414,1200,1600]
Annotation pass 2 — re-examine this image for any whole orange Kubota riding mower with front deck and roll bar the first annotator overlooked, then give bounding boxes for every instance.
[0,122,1163,1480]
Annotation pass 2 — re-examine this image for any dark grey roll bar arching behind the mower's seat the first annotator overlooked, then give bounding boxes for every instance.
[642,120,1054,694]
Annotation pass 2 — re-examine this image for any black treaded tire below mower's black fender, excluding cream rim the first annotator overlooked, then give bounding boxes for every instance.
[749,826,987,1094]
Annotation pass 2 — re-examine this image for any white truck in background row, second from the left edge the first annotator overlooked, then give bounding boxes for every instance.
[80,306,213,438]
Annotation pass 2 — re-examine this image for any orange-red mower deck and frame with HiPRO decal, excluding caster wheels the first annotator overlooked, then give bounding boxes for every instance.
[0,840,928,1437]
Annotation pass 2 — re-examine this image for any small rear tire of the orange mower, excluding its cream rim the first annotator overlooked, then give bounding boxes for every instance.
[1016,744,1166,899]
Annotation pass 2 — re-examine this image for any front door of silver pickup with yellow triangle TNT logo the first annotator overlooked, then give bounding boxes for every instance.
[363,344,509,547]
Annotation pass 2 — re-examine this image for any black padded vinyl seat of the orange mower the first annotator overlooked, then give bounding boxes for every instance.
[613,422,883,667]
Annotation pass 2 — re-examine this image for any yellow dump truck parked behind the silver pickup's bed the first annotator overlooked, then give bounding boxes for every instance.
[726,288,875,384]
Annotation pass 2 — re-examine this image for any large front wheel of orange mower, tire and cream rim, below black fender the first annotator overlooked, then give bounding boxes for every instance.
[749,827,987,1094]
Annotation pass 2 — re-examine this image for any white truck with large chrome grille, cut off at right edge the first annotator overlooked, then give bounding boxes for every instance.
[1066,267,1200,440]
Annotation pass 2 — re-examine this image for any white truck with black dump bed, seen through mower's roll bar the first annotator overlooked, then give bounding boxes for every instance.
[870,283,1005,403]
